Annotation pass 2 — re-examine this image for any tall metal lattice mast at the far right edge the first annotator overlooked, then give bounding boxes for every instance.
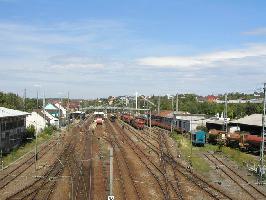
[259,83,266,184]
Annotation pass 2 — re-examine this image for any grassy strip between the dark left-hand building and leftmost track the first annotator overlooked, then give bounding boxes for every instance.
[3,133,52,167]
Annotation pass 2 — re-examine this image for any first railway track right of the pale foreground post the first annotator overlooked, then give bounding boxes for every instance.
[106,121,144,200]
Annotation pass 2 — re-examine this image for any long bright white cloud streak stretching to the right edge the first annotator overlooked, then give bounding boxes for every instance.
[137,44,266,69]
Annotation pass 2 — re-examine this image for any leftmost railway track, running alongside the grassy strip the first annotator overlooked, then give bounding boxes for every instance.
[0,141,56,190]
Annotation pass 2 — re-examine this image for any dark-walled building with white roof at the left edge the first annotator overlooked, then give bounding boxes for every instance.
[0,107,29,153]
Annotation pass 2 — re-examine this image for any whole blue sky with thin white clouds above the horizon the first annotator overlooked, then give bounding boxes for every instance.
[0,0,266,98]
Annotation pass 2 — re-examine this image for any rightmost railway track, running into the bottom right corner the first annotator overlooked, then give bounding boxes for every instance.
[204,153,266,199]
